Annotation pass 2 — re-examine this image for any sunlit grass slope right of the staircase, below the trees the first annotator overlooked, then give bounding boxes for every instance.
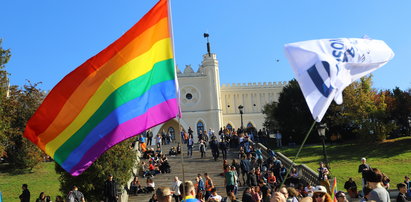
[276,137,411,191]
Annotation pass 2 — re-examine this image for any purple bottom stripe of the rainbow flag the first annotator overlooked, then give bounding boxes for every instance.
[70,98,179,176]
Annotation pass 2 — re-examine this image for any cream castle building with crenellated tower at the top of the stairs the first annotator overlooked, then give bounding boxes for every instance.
[152,53,287,141]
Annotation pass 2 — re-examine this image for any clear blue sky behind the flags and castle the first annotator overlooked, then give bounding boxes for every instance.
[0,0,411,90]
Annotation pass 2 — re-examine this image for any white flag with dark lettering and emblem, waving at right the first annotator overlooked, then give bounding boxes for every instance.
[284,38,394,122]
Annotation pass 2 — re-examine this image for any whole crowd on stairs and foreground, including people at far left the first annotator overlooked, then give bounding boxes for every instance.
[20,125,411,202]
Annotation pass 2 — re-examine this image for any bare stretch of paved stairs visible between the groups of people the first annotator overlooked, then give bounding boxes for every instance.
[129,144,243,202]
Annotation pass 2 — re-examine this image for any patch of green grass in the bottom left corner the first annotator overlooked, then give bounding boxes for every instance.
[0,162,62,201]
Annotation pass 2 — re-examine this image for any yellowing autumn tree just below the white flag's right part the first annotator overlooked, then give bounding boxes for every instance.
[326,76,395,141]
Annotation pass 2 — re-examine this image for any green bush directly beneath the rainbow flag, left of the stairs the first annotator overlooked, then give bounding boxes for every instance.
[55,138,137,201]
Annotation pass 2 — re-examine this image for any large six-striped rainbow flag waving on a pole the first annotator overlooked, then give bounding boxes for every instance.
[24,0,180,176]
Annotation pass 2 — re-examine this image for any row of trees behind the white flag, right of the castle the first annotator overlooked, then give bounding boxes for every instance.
[263,76,411,142]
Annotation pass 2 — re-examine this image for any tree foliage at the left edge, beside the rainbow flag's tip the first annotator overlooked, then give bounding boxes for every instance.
[0,40,44,170]
